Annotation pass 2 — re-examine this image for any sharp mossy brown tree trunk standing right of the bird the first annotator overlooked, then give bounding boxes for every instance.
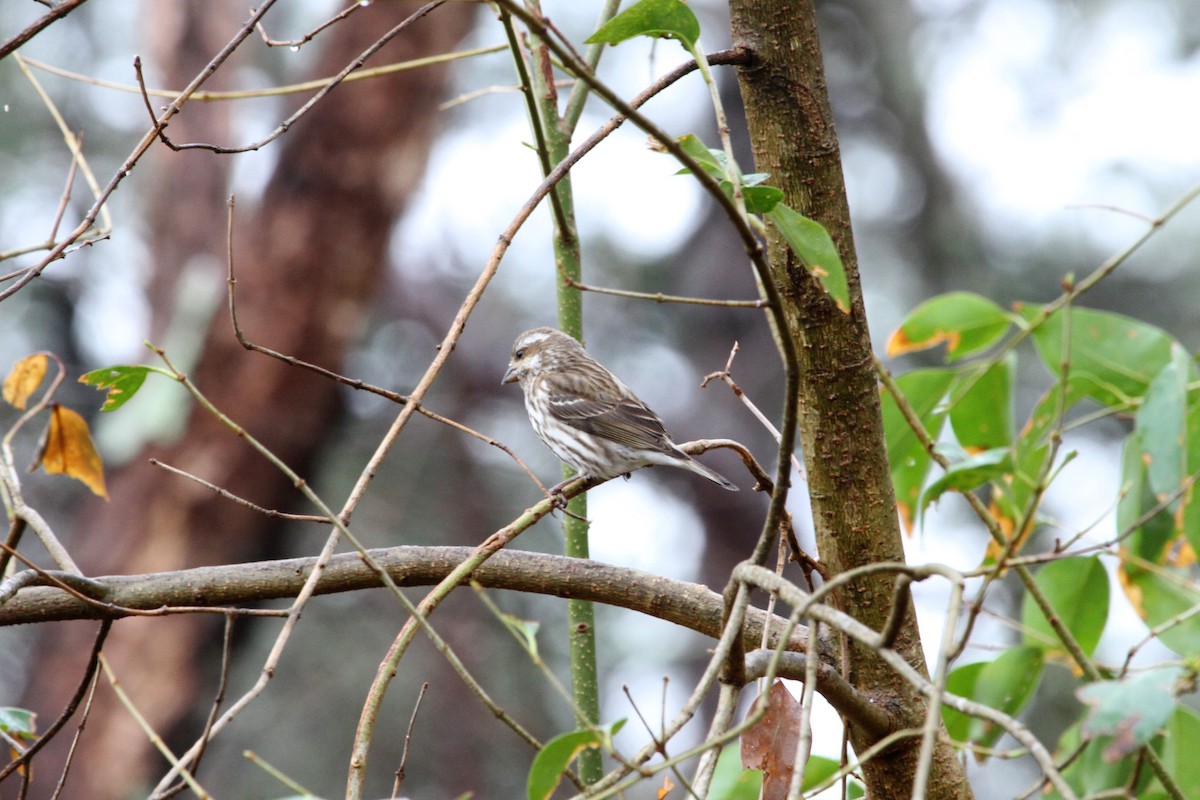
[730,0,971,799]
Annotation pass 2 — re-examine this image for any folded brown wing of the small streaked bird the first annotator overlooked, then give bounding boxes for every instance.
[545,363,678,455]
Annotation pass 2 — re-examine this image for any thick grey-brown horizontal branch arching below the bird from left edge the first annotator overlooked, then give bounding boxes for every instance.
[0,547,808,650]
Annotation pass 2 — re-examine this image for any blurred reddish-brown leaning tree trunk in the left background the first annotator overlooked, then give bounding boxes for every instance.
[24,2,473,800]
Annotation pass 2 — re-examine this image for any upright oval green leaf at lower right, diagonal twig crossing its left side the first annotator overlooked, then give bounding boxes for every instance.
[1021,557,1109,655]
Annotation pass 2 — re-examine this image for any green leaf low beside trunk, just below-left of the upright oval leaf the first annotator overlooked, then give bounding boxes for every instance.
[942,646,1045,747]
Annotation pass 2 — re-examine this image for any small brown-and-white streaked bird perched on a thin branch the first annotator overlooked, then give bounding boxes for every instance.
[500,327,738,492]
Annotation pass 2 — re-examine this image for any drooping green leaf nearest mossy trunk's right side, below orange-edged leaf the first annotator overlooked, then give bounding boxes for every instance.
[880,368,955,530]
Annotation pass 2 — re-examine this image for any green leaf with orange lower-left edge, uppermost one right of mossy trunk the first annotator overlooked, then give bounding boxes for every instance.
[887,291,1012,362]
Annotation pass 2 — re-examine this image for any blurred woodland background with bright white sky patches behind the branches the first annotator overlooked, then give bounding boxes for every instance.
[0,0,1200,798]
